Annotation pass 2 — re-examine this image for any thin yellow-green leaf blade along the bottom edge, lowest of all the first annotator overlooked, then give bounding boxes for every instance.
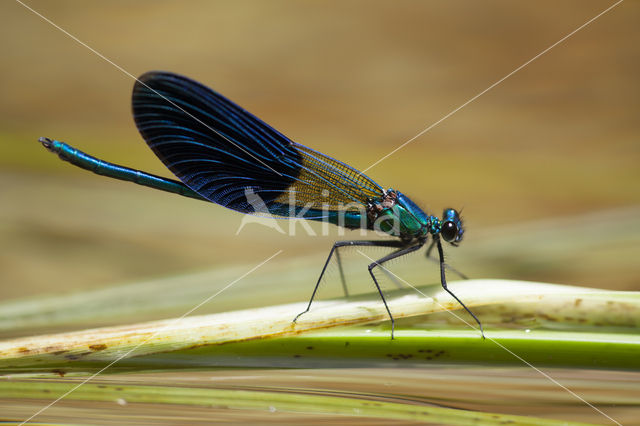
[0,381,596,425]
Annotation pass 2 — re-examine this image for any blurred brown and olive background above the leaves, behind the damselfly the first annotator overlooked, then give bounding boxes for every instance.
[0,1,640,301]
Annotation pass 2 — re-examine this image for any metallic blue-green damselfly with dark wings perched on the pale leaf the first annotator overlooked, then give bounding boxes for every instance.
[40,72,484,338]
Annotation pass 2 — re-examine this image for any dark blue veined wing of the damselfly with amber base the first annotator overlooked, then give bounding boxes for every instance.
[133,72,382,217]
